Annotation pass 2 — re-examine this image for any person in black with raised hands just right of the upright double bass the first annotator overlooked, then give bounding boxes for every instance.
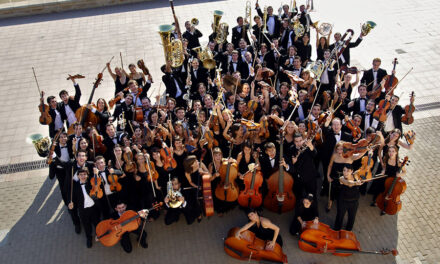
[289,133,319,197]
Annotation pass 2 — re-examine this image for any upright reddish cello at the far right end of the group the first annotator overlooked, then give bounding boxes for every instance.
[376,156,408,215]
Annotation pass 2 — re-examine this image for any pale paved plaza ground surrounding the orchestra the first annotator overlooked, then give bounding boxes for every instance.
[0,0,440,263]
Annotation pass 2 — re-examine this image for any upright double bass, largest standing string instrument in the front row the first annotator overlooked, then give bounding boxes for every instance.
[264,130,296,214]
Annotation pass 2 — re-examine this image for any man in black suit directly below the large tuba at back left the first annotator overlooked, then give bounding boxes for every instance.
[161,65,186,107]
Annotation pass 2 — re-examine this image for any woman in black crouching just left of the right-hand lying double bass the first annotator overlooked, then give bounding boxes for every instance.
[289,193,319,236]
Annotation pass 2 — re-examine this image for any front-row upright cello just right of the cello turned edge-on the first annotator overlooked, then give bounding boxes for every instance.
[215,143,238,202]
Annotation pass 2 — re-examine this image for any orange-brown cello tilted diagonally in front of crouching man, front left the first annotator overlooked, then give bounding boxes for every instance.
[96,202,163,247]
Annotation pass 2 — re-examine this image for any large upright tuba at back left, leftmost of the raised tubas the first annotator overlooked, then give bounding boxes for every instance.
[159,25,185,68]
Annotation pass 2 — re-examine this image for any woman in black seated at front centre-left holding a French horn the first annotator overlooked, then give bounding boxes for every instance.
[164,178,202,225]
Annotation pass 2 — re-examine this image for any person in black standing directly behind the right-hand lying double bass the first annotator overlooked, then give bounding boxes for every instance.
[334,164,364,231]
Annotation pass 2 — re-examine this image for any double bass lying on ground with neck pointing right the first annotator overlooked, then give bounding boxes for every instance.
[298,221,398,257]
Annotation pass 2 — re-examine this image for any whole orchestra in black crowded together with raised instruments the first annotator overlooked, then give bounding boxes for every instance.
[35,1,415,260]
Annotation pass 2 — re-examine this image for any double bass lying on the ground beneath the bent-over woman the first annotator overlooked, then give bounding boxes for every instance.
[224,227,287,263]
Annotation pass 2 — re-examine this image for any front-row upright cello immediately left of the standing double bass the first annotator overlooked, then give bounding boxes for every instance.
[238,164,263,208]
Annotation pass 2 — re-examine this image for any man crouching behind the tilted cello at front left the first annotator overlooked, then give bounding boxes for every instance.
[111,201,148,253]
